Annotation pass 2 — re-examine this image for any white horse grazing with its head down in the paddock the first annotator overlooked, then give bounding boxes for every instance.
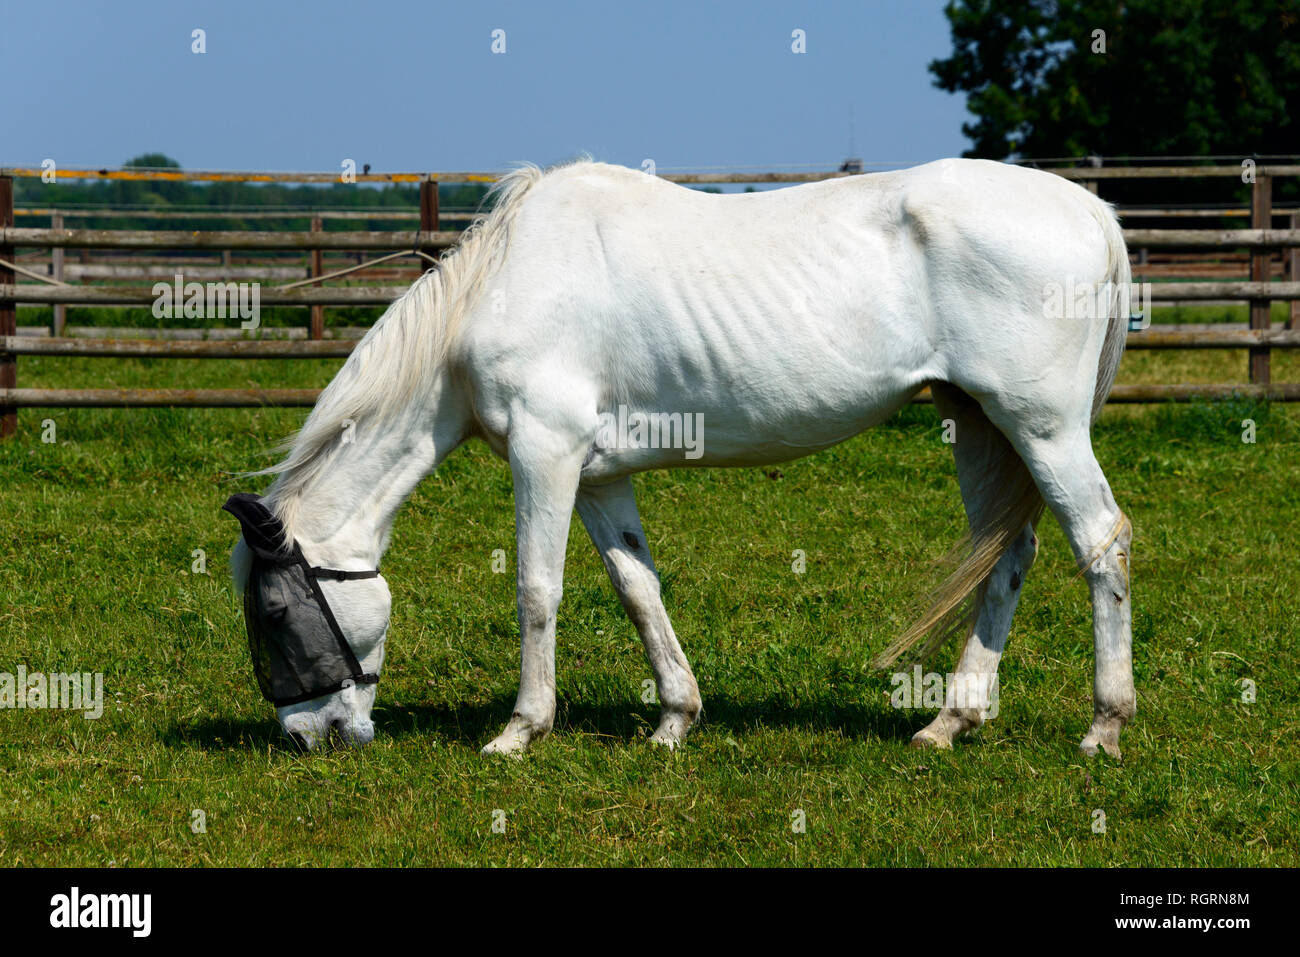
[233,160,1136,755]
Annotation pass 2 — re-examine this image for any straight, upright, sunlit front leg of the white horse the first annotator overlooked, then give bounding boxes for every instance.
[482,413,588,754]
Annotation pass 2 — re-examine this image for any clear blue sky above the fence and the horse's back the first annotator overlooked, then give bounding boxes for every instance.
[0,0,967,172]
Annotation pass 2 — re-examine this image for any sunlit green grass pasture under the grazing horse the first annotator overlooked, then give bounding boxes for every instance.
[0,306,1300,866]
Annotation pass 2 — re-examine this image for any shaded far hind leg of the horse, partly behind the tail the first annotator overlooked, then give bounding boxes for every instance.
[911,384,1039,749]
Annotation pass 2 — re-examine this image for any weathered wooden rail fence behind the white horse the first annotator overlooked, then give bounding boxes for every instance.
[0,165,1300,438]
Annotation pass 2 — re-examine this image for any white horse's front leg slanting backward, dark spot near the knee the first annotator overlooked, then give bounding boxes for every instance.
[577,479,702,748]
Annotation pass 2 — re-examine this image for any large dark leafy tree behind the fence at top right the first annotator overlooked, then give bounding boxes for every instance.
[930,0,1300,159]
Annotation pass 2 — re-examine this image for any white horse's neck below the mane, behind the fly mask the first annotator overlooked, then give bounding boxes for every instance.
[267,376,465,571]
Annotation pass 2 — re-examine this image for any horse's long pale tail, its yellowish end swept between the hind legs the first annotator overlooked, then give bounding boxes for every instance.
[872,192,1132,668]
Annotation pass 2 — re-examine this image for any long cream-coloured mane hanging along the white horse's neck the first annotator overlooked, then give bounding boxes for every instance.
[247,164,564,537]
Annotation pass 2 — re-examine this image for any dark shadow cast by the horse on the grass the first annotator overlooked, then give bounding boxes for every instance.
[163,696,933,753]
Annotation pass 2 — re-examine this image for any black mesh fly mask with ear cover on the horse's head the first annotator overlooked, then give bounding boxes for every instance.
[221,493,380,707]
